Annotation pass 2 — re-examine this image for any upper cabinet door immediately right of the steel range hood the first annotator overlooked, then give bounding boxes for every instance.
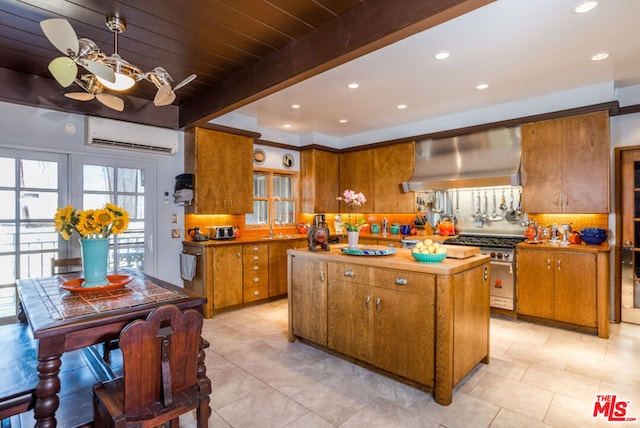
[522,119,562,213]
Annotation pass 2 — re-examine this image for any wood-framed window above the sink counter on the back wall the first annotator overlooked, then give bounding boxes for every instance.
[245,170,296,228]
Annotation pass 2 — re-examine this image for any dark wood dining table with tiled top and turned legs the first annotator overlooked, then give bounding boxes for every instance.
[17,269,206,428]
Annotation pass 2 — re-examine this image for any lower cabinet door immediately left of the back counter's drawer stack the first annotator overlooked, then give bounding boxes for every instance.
[212,245,243,309]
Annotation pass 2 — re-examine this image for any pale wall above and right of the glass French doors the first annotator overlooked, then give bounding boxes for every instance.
[0,102,184,286]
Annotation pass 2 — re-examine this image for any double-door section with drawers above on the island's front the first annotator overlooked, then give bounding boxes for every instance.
[327,263,436,386]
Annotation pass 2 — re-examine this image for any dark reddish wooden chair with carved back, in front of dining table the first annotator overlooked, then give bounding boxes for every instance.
[93,305,211,428]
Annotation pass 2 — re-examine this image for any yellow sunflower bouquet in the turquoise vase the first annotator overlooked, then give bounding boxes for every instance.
[54,204,129,241]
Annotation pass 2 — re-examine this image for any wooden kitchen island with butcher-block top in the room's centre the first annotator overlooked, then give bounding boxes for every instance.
[287,245,490,405]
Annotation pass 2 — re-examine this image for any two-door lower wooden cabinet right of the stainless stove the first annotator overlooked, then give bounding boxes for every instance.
[517,249,597,327]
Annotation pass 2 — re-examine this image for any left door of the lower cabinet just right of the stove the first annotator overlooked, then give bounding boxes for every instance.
[517,249,555,319]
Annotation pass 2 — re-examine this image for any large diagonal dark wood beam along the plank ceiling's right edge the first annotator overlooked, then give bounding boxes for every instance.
[178,0,495,128]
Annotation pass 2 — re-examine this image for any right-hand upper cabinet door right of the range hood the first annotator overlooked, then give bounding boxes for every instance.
[561,112,610,214]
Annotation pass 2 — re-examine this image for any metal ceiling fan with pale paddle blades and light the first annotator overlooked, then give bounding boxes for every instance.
[40,16,196,111]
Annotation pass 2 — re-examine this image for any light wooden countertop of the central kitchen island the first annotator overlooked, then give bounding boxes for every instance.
[287,244,491,275]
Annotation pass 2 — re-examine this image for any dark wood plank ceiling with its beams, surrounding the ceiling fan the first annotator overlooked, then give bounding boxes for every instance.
[0,0,493,129]
